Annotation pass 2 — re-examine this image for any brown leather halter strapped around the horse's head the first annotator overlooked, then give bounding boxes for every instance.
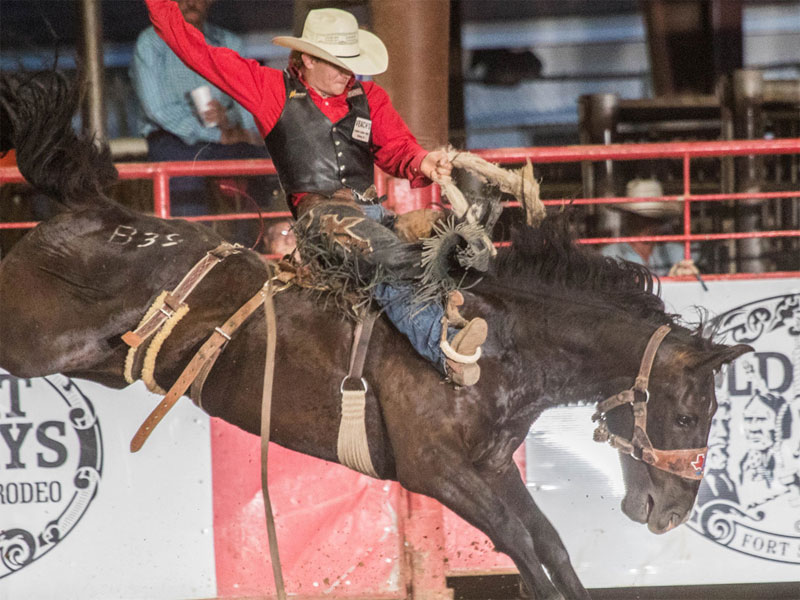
[592,325,708,479]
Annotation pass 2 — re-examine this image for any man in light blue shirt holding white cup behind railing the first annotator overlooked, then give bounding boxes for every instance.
[131,0,268,216]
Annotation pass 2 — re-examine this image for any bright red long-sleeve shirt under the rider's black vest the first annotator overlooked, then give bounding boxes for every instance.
[145,0,431,193]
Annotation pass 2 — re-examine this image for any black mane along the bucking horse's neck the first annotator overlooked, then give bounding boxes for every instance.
[481,213,672,323]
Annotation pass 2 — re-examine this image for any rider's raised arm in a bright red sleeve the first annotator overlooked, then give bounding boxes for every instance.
[145,0,286,135]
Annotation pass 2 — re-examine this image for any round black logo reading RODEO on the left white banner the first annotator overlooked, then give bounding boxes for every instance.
[0,371,103,579]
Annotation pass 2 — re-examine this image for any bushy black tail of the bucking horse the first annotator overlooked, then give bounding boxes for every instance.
[0,71,118,207]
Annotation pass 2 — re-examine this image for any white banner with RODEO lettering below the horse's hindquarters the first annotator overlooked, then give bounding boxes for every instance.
[0,378,216,600]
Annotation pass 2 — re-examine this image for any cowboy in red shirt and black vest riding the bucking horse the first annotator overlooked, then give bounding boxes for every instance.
[146,0,487,385]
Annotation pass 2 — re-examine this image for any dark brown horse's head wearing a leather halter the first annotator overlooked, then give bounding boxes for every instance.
[599,337,752,533]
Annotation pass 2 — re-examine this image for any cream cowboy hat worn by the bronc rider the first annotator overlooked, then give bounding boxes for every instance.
[272,8,389,75]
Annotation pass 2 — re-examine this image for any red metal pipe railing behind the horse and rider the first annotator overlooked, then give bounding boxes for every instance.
[0,138,800,279]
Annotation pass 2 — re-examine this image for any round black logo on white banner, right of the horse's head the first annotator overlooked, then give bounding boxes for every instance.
[689,294,800,564]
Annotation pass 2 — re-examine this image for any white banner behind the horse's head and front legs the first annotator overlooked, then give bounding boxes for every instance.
[527,279,800,587]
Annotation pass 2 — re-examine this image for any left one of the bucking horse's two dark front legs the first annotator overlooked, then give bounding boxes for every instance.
[399,449,568,600]
